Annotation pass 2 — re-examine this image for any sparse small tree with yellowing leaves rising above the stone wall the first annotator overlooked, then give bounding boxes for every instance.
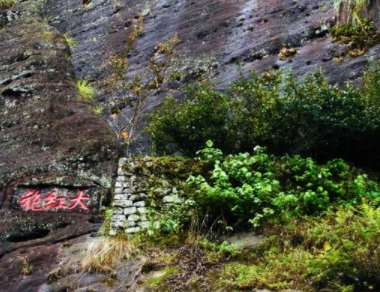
[107,15,180,153]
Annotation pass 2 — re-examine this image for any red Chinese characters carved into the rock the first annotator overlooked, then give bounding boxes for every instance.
[18,190,90,212]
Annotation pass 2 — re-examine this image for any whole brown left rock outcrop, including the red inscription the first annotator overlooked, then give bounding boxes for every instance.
[0,0,118,291]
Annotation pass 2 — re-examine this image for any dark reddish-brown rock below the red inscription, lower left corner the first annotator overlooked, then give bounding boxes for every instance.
[0,209,99,292]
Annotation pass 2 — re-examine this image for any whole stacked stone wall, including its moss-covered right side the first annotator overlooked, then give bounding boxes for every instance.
[110,157,202,235]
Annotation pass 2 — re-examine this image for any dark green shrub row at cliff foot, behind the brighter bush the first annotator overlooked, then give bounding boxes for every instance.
[147,65,380,167]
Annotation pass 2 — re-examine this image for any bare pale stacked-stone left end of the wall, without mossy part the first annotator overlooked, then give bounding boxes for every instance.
[110,158,148,235]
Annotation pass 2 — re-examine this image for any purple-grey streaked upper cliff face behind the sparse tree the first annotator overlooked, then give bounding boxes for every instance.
[46,0,380,152]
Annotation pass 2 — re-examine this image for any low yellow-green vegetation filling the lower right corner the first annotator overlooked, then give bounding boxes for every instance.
[216,204,380,291]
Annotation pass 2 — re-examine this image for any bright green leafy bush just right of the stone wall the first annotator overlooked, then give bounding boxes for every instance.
[188,142,380,228]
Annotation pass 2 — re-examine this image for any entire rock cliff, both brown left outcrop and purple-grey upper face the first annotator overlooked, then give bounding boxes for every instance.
[0,0,380,291]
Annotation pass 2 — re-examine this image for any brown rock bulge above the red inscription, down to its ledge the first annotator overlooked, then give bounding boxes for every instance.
[0,18,117,205]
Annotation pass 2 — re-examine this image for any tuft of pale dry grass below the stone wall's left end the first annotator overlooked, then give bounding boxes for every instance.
[80,237,136,273]
